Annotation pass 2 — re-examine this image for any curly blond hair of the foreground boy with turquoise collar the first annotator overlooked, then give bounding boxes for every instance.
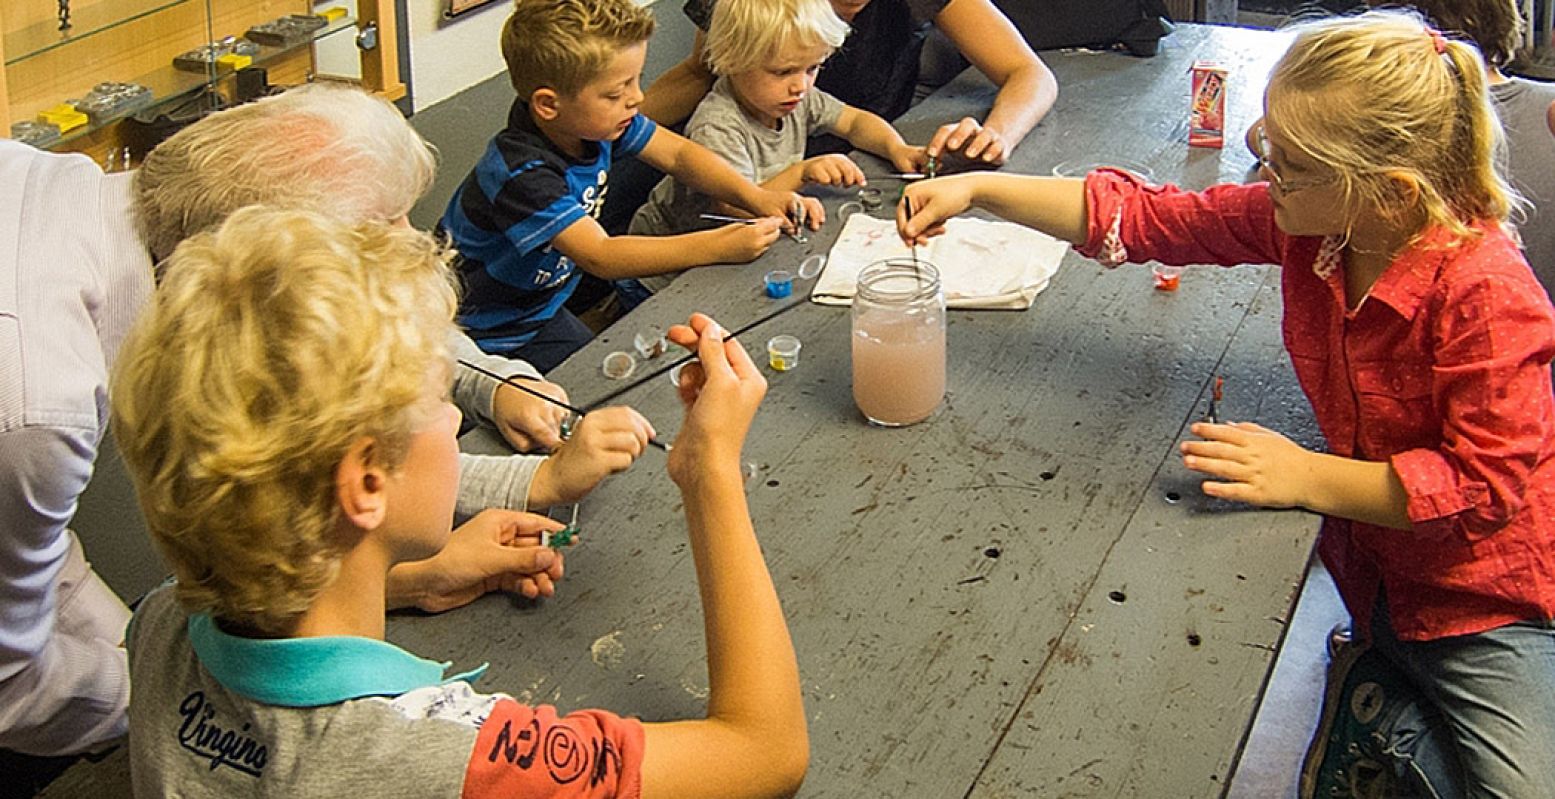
[110,207,456,636]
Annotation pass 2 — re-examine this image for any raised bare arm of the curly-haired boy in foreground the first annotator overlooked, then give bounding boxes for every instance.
[642,314,810,799]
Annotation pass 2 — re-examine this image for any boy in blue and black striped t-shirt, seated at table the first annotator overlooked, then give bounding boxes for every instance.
[440,0,799,372]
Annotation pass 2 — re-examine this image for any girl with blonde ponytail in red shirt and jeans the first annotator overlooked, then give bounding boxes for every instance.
[897,12,1555,797]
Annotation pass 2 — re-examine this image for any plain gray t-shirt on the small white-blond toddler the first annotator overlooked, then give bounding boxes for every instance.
[628,78,846,236]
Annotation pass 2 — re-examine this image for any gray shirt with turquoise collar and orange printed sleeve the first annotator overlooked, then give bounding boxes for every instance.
[129,584,644,799]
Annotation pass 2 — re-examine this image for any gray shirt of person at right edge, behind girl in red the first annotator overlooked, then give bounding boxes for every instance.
[1490,78,1555,297]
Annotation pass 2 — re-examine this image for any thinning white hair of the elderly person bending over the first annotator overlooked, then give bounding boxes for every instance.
[135,82,437,260]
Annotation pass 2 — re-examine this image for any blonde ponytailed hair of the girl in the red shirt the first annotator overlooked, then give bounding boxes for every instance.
[1267,11,1518,241]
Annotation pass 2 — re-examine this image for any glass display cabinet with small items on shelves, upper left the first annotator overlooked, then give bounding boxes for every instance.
[0,0,404,158]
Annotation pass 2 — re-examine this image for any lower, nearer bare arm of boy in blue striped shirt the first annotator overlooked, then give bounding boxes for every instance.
[550,216,784,280]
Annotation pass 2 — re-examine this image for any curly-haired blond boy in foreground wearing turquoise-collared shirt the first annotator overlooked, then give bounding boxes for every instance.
[112,208,807,797]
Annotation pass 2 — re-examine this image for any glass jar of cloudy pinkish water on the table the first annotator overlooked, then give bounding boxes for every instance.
[852,258,945,427]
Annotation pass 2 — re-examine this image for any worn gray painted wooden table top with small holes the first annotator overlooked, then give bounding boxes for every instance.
[51,25,1317,797]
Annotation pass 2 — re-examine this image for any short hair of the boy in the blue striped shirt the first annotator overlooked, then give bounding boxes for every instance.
[502,0,653,101]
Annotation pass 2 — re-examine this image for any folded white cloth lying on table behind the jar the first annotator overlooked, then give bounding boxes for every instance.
[810,213,1068,311]
